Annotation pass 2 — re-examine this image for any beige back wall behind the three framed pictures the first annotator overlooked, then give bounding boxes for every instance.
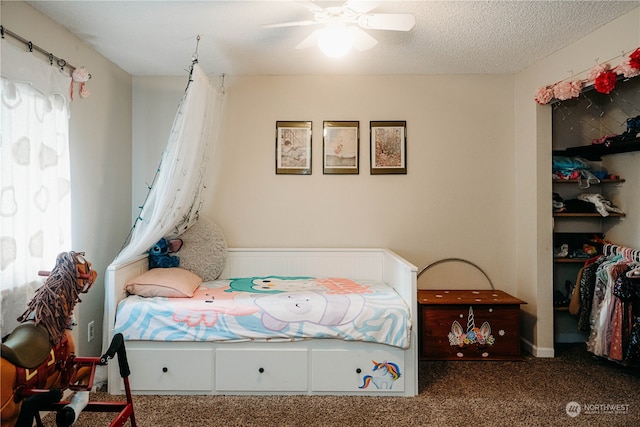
[133,75,517,293]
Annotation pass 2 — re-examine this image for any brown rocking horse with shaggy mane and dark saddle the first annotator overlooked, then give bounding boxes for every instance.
[0,252,136,427]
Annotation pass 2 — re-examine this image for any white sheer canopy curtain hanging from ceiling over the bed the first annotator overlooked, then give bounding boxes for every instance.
[113,63,224,264]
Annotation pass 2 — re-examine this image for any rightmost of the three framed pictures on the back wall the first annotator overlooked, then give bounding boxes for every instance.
[370,121,407,175]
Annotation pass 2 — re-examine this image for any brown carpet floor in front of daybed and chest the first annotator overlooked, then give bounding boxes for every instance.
[43,344,640,427]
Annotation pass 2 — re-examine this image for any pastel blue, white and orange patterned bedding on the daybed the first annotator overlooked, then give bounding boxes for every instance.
[115,276,411,348]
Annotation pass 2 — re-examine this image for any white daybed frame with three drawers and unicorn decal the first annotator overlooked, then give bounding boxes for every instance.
[105,248,418,396]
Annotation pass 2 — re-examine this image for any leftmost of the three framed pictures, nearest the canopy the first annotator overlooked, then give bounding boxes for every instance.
[276,121,311,175]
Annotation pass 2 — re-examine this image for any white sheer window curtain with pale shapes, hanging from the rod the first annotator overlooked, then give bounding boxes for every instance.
[0,40,71,336]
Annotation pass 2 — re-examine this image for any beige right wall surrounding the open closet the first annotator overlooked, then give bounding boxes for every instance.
[515,8,640,356]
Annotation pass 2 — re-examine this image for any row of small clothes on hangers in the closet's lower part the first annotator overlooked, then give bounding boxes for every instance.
[578,244,640,366]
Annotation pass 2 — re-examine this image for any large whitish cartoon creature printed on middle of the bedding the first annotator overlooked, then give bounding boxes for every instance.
[255,291,364,331]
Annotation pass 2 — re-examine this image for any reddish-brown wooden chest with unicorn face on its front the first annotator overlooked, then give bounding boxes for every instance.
[418,290,526,360]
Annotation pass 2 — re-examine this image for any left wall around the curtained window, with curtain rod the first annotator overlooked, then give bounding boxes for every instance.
[0,1,131,356]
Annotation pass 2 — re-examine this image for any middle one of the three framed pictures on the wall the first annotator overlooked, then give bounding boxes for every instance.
[322,121,360,175]
